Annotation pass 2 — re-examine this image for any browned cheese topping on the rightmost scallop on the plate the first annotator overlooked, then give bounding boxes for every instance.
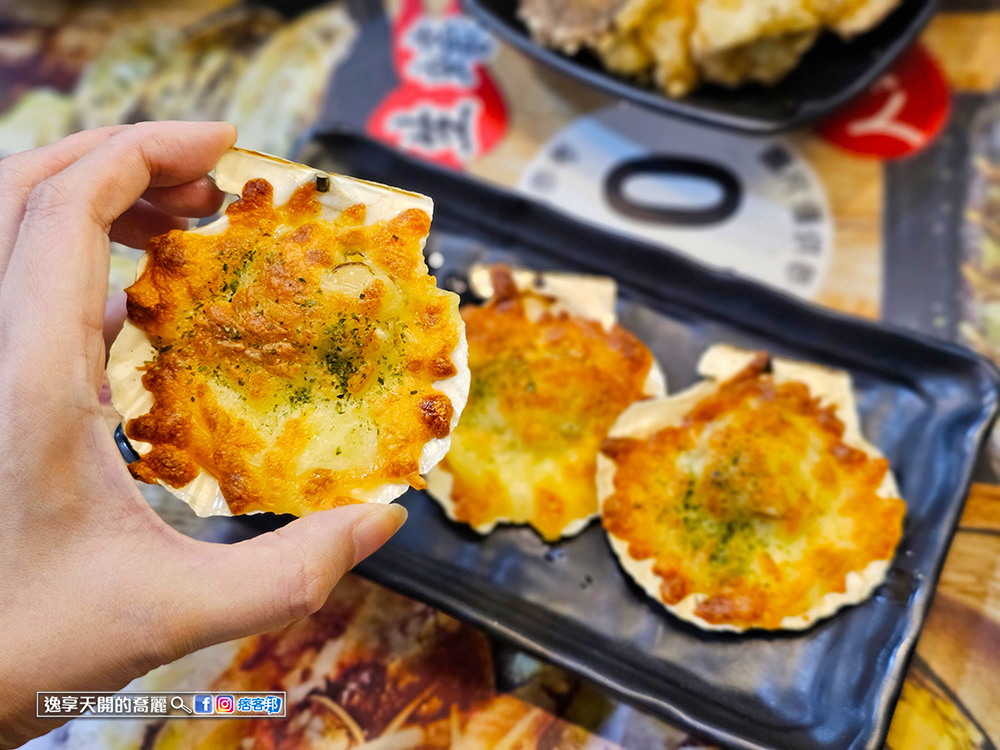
[601,357,905,629]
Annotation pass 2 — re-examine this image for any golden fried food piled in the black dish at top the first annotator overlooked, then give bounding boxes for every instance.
[520,0,912,97]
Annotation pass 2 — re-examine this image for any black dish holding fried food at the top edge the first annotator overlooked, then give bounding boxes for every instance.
[462,0,936,133]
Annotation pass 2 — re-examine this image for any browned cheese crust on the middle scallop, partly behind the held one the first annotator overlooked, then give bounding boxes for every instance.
[438,268,653,540]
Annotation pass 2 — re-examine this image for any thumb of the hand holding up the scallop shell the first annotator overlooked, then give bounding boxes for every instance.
[164,504,406,656]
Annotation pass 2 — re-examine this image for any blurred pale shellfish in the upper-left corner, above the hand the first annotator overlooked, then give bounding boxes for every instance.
[0,0,356,156]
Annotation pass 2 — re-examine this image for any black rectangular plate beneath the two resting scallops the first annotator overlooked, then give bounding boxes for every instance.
[286,134,1000,748]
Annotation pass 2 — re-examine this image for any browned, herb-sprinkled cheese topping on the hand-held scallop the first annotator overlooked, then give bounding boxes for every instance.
[126,179,460,514]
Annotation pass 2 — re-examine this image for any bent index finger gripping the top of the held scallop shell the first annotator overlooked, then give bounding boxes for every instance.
[0,122,236,388]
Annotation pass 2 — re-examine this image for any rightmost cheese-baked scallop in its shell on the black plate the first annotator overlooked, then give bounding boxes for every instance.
[597,346,906,631]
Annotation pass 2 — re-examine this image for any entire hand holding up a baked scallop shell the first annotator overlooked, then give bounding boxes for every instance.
[0,123,406,748]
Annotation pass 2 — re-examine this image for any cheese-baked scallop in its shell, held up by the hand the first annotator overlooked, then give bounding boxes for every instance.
[108,149,469,516]
